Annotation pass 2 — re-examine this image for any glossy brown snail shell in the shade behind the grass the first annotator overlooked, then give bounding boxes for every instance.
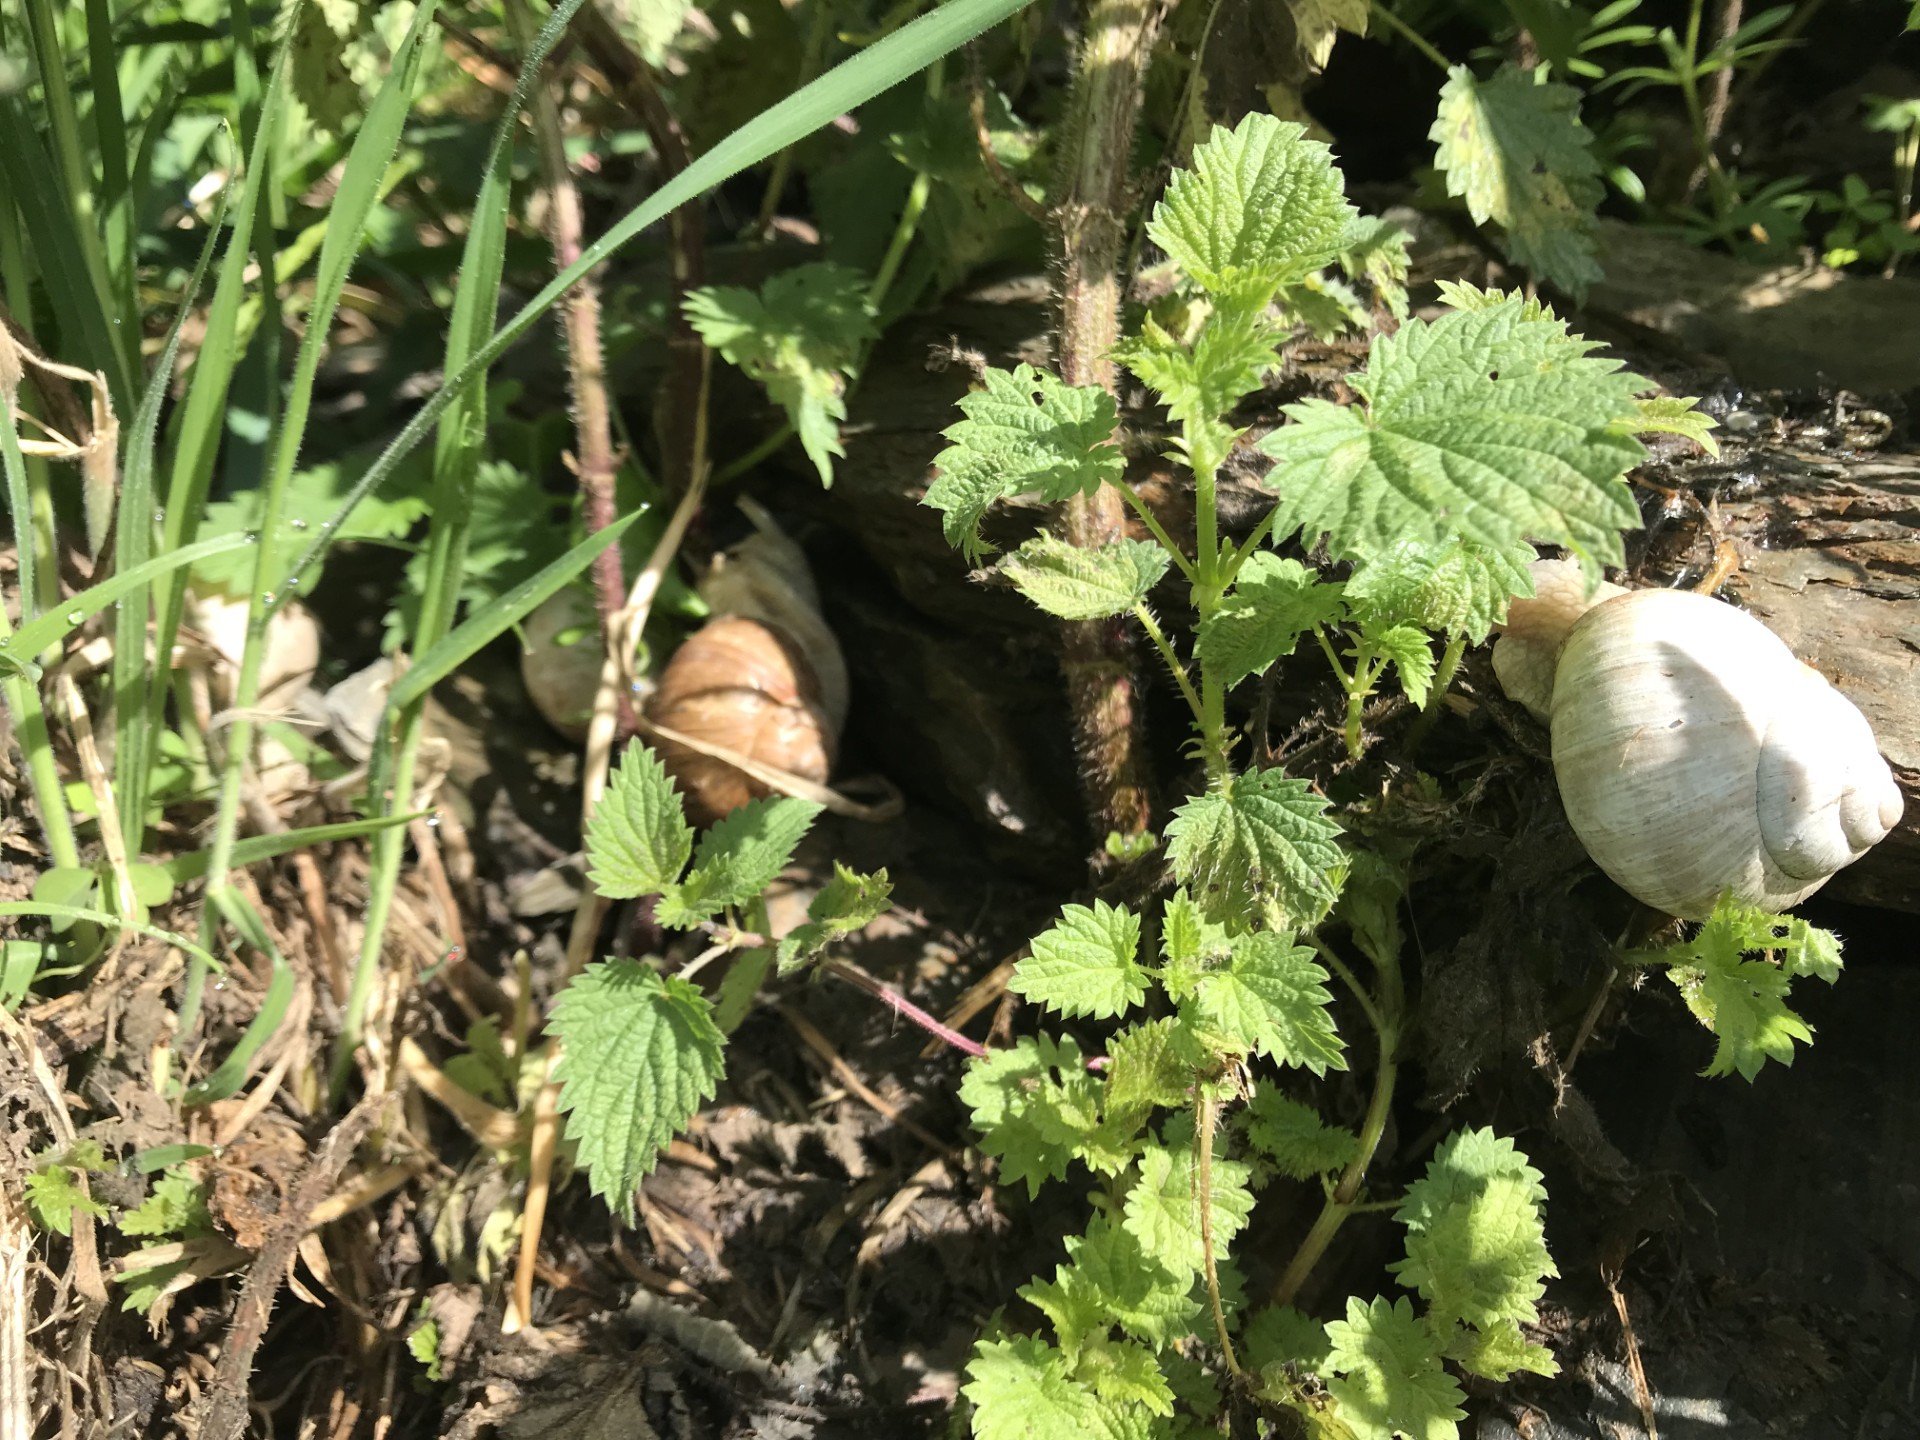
[647,616,839,826]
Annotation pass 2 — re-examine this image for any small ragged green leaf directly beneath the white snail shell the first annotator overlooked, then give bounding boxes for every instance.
[1636,895,1841,1081]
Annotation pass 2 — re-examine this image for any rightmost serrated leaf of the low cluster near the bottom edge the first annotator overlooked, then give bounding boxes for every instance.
[1388,1175,1559,1329]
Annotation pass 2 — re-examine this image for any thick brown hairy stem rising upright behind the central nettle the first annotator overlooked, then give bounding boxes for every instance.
[1050,0,1160,835]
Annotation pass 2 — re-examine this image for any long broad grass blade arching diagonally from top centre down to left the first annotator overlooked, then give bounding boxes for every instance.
[275,0,1031,607]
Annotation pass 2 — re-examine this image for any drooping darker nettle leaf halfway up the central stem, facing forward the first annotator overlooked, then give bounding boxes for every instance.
[1167,770,1340,924]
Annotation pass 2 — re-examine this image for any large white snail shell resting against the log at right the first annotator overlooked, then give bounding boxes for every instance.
[1494,561,1905,920]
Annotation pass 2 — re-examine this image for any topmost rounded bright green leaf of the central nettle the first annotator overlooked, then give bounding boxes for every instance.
[1146,113,1354,303]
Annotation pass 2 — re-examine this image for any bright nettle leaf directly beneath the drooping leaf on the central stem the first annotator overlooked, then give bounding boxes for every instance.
[1181,931,1346,1075]
